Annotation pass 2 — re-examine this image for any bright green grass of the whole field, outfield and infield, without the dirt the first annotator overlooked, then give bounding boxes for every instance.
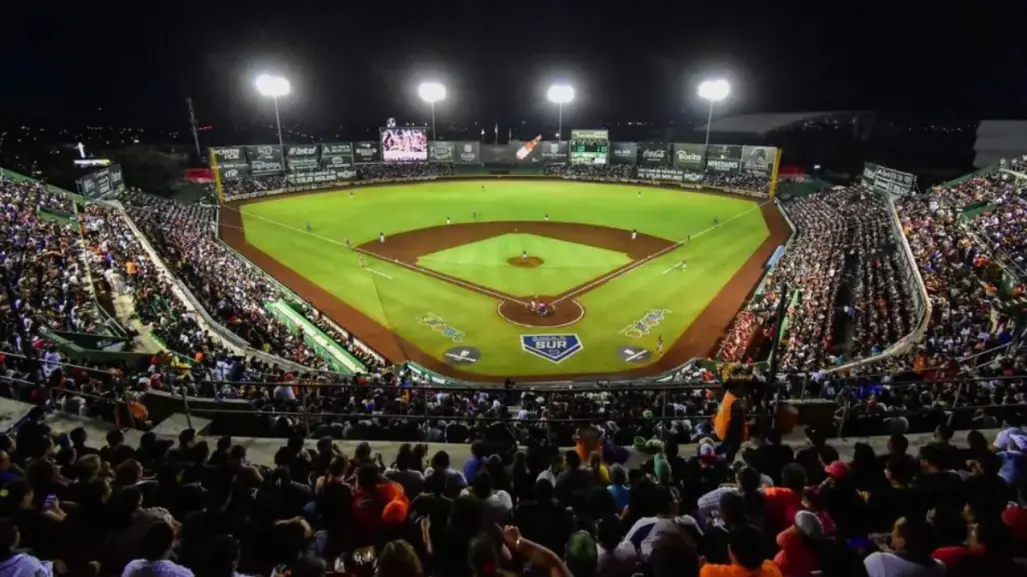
[242,181,769,376]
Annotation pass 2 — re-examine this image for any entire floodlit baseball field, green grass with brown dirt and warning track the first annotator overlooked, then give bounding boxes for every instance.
[221,180,789,380]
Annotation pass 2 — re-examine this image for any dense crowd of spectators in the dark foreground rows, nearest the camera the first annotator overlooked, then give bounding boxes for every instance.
[10,402,1027,577]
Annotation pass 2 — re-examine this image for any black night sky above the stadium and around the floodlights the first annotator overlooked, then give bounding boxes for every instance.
[0,0,1027,128]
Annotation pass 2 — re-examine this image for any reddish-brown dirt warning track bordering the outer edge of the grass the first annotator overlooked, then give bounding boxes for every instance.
[219,182,791,383]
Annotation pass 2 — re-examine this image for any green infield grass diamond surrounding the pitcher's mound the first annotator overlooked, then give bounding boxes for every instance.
[417,234,632,297]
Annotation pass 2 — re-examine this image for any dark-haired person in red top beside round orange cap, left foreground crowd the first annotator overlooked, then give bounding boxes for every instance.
[353,465,410,547]
